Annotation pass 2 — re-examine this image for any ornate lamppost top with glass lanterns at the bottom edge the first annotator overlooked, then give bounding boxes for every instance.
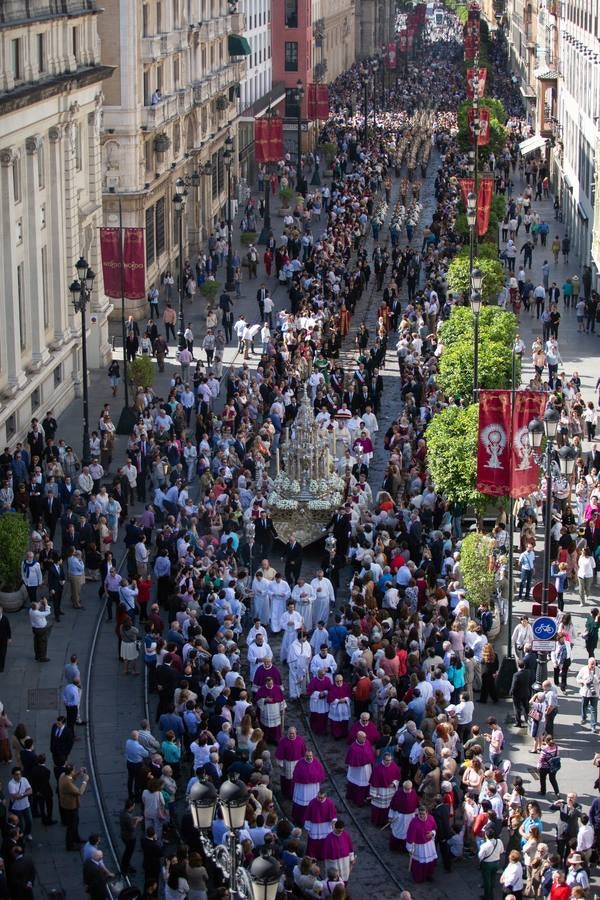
[189,780,281,900]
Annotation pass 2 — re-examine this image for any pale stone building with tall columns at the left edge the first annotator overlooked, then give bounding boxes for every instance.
[0,0,111,447]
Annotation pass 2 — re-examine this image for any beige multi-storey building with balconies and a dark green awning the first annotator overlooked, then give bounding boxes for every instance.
[99,0,250,317]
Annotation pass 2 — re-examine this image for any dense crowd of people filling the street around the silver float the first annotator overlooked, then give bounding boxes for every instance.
[0,12,600,900]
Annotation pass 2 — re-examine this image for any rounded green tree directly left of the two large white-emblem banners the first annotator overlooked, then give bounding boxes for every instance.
[426,403,488,512]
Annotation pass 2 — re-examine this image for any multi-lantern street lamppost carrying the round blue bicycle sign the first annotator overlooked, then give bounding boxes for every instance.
[528,406,577,686]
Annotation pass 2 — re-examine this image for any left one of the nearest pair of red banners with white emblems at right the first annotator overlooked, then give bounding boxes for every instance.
[477,391,511,497]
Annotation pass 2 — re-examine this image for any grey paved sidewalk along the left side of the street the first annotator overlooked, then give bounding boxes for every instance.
[0,172,336,897]
